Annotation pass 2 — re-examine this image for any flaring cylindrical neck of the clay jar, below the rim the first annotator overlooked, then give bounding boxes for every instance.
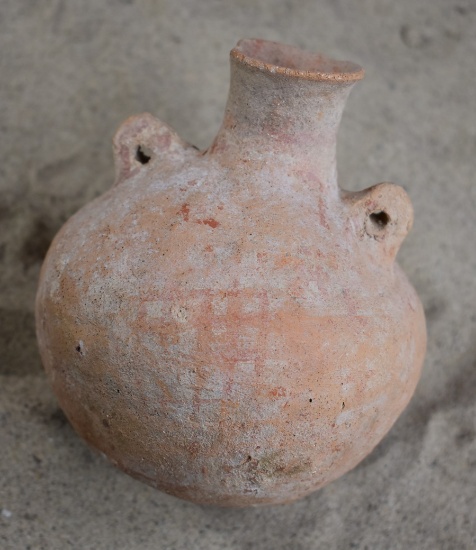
[209,51,355,194]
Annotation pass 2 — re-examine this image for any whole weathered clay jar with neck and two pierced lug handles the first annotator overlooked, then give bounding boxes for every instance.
[37,40,426,506]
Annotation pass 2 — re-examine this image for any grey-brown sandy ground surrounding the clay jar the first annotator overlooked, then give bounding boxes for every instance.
[0,0,476,550]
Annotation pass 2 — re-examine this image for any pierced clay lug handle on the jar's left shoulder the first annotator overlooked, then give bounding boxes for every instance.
[113,113,196,185]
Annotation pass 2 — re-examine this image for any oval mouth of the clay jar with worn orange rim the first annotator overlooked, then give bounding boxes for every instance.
[230,38,364,82]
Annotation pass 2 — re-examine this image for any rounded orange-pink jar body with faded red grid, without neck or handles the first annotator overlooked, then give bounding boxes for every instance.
[38,143,424,505]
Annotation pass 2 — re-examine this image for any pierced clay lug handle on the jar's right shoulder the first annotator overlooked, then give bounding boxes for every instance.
[344,182,413,262]
